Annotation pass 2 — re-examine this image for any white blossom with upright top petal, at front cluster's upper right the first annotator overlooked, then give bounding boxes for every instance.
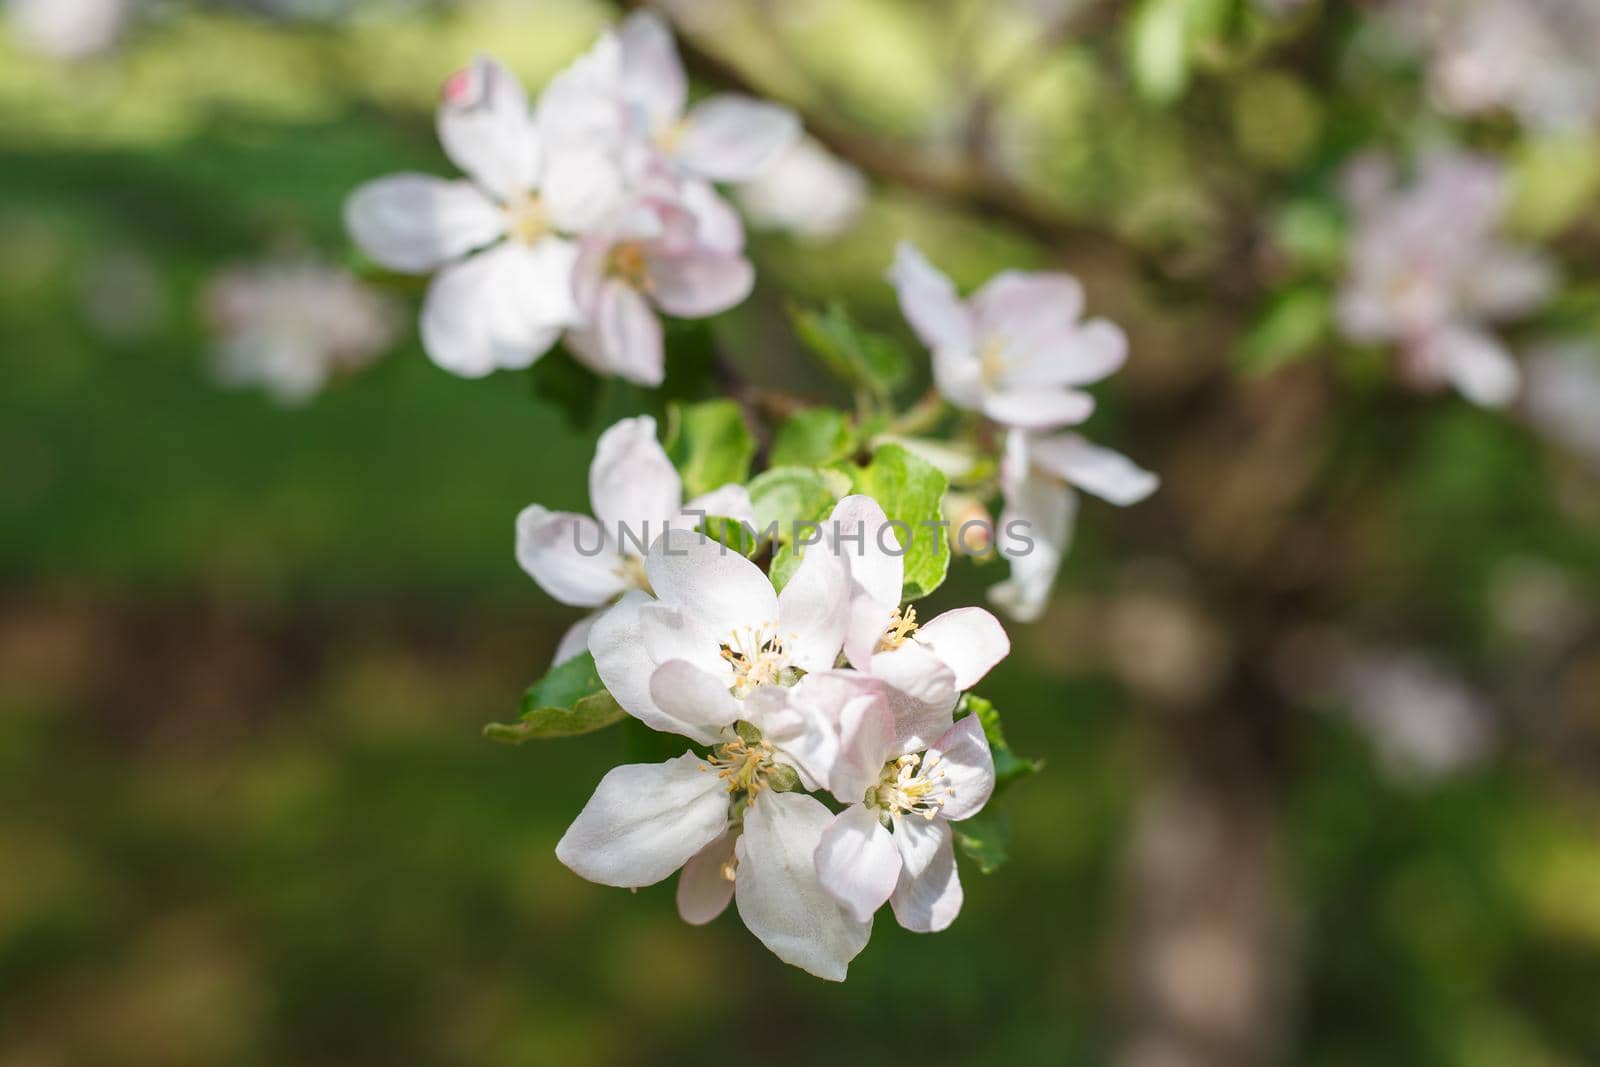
[824,494,1011,752]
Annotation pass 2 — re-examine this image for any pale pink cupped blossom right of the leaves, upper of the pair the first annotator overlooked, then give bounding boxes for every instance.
[890,242,1128,430]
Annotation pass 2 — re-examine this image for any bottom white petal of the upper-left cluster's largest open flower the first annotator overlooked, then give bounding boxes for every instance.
[421,242,571,378]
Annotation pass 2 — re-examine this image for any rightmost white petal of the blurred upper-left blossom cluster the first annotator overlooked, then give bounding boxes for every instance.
[734,138,867,240]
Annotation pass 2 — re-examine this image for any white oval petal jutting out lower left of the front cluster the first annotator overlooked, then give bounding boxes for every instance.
[555,752,728,888]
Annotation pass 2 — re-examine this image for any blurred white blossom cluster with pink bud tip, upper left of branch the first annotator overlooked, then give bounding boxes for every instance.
[346,13,800,386]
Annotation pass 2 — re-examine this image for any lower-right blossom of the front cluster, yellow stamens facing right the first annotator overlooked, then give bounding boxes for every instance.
[816,704,995,933]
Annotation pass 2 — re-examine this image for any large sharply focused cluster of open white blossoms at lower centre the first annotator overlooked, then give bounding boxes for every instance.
[544,495,1010,981]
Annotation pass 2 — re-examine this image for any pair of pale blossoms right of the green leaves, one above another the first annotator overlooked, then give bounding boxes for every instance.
[890,245,1160,622]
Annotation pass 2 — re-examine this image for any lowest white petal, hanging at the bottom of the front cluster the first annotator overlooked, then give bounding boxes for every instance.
[734,792,872,982]
